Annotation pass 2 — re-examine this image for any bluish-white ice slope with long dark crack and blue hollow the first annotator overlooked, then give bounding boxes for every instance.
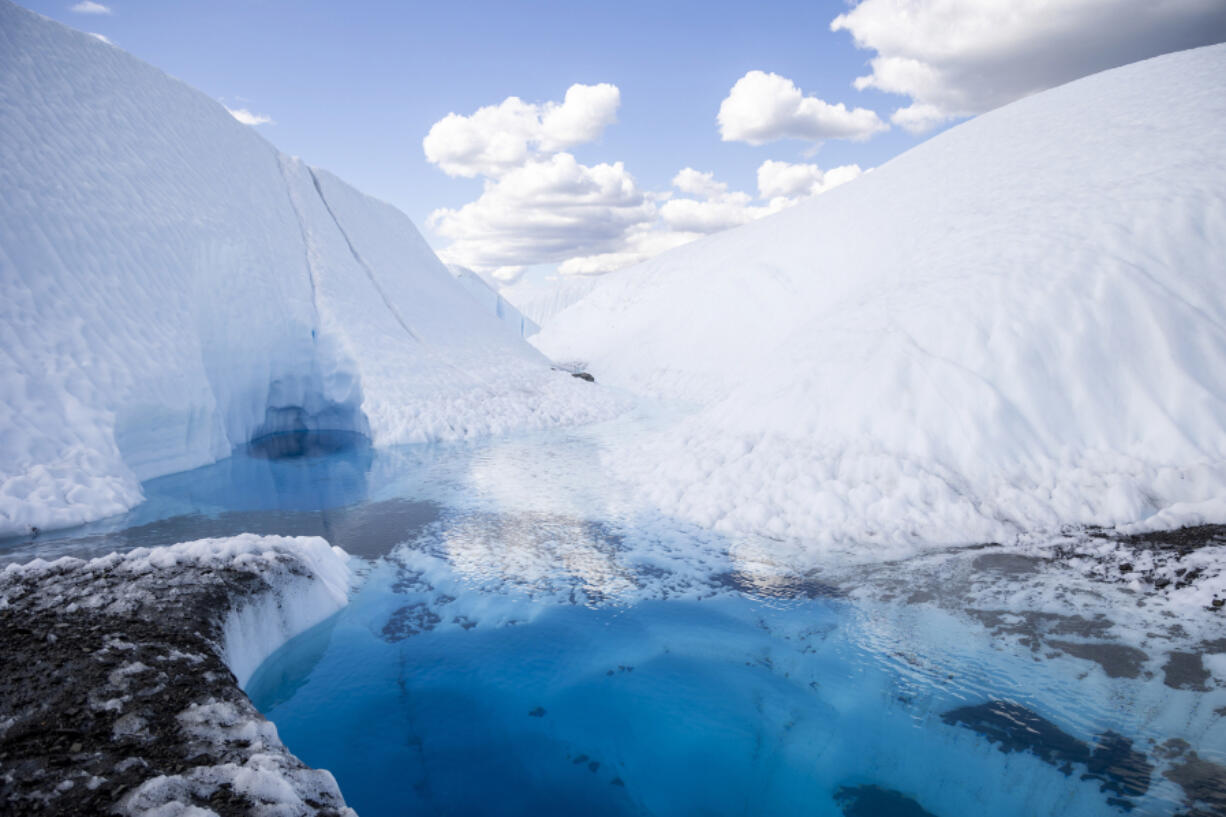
[0,6,608,535]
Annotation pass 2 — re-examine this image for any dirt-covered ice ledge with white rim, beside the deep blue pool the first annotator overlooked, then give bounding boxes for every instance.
[0,534,353,817]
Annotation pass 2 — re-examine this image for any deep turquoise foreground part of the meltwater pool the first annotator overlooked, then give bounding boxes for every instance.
[248,514,1213,817]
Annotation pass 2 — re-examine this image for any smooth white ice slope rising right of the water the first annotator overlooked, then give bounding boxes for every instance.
[536,45,1226,553]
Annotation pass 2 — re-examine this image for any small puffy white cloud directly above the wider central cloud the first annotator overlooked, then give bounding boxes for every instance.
[422,82,622,178]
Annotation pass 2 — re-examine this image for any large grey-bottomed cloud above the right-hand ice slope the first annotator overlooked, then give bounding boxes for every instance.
[830,0,1226,132]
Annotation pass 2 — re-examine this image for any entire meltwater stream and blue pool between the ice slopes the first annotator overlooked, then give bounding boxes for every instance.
[0,417,1226,817]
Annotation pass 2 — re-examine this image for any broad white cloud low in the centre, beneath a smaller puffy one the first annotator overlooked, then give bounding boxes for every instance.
[427,153,656,278]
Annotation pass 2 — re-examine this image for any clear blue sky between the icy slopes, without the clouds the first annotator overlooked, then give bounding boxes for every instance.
[26,0,916,226]
